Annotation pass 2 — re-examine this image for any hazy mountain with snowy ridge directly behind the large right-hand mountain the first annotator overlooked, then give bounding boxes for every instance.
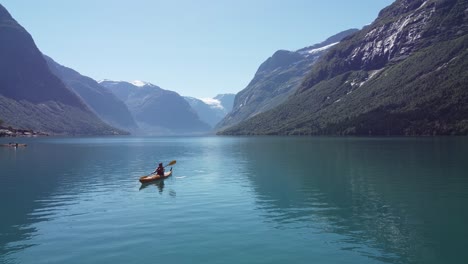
[217,29,357,130]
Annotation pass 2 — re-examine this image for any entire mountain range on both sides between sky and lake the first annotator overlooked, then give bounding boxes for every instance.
[0,0,468,136]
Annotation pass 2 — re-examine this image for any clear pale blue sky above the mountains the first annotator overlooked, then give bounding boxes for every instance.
[1,0,393,98]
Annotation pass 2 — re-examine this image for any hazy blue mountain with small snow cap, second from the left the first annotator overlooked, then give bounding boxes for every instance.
[100,80,210,134]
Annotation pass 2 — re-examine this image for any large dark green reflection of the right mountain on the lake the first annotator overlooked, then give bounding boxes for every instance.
[236,138,468,263]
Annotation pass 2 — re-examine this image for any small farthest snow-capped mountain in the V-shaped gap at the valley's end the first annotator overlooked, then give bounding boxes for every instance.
[184,94,235,127]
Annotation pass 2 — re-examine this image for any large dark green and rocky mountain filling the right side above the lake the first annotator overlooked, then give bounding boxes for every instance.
[221,0,468,135]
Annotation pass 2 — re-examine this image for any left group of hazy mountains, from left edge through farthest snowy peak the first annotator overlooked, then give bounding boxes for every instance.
[0,5,234,135]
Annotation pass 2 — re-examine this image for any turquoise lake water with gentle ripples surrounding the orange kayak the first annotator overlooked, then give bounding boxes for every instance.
[0,137,468,263]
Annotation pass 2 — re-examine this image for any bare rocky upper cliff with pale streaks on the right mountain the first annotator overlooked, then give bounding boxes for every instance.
[298,0,466,92]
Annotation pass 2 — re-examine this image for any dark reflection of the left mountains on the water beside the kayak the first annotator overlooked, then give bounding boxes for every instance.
[0,138,164,262]
